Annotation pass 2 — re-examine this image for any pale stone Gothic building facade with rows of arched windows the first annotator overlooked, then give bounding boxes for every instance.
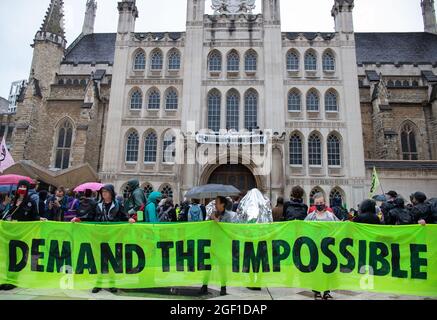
[13,0,437,204]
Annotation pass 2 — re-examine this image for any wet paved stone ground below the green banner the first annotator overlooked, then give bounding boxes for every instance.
[0,287,437,300]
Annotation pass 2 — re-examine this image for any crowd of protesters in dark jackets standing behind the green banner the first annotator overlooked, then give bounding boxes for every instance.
[0,179,437,300]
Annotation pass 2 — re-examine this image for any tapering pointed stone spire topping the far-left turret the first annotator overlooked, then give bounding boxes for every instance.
[35,0,67,48]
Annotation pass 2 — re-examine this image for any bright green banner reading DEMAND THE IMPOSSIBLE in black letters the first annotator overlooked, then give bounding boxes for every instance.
[0,221,437,296]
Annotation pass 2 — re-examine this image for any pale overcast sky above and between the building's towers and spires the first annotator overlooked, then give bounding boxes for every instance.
[0,0,430,98]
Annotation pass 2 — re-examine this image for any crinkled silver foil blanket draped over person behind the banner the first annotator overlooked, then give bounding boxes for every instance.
[237,189,273,223]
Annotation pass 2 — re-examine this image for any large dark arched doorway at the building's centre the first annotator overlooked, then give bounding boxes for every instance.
[208,164,257,193]
